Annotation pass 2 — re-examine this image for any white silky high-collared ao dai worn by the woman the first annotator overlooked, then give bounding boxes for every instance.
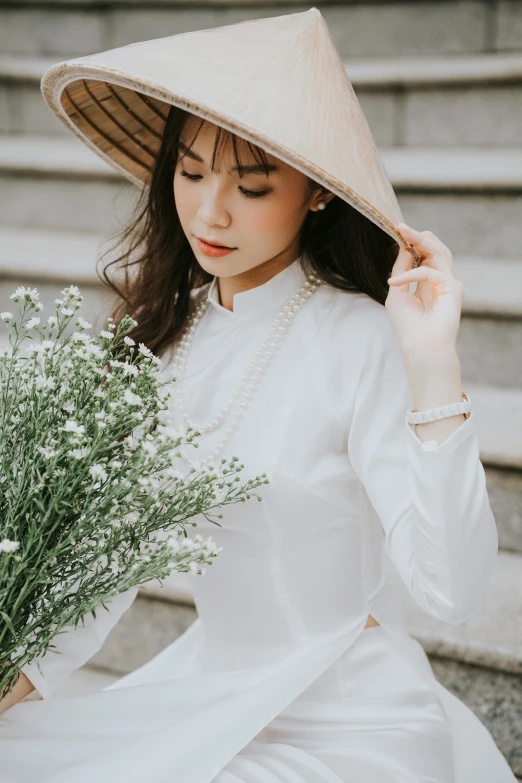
[0,259,515,783]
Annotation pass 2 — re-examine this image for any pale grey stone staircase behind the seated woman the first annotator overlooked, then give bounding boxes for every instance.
[0,0,522,783]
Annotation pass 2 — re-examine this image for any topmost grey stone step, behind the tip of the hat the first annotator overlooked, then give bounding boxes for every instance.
[0,0,522,59]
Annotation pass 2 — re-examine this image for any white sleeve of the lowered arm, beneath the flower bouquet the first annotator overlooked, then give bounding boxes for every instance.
[21,587,138,699]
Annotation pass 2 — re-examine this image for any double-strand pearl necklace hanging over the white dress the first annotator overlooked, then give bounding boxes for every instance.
[167,274,322,467]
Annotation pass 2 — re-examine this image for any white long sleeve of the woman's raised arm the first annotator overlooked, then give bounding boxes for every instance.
[348,307,498,623]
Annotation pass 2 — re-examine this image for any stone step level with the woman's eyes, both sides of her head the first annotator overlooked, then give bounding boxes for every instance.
[0,134,522,259]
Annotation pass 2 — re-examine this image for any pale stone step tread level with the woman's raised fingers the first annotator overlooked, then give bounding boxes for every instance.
[4,225,522,316]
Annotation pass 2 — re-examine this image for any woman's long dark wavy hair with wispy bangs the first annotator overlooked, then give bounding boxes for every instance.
[98,106,399,356]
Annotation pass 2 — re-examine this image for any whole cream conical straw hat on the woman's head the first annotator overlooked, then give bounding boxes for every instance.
[41,8,419,265]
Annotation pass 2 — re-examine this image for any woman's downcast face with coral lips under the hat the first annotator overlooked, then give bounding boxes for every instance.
[174,117,333,277]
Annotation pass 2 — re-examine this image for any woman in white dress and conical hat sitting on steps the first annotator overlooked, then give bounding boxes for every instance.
[0,9,515,783]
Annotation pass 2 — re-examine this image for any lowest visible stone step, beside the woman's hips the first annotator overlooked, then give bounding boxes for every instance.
[85,552,522,775]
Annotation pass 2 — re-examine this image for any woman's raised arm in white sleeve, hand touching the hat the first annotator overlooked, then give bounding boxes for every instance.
[348,224,498,623]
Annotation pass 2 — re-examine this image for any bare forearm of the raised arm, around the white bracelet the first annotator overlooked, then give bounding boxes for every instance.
[402,350,465,444]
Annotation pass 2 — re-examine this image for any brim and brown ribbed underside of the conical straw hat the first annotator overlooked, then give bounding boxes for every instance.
[41,63,420,266]
